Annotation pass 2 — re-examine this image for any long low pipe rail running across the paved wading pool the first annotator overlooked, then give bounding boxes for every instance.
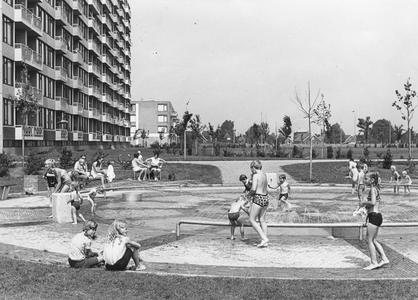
[176,220,418,240]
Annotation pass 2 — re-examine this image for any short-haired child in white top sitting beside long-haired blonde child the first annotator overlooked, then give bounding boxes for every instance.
[68,220,103,269]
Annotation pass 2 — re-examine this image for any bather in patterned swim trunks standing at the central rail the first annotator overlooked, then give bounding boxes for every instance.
[249,160,269,248]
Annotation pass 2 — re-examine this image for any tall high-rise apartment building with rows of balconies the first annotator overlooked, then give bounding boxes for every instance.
[0,0,132,154]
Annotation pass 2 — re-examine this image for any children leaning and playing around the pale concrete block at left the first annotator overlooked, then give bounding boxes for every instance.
[44,159,104,224]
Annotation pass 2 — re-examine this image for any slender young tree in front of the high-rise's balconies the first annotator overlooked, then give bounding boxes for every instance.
[9,65,40,167]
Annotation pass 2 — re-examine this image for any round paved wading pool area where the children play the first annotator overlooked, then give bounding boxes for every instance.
[0,185,418,279]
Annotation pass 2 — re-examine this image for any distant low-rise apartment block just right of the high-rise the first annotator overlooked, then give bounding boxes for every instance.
[131,100,178,146]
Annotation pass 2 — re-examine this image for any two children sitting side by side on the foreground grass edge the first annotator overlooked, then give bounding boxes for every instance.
[68,219,146,271]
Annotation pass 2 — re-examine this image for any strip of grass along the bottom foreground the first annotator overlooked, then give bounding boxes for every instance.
[0,258,418,300]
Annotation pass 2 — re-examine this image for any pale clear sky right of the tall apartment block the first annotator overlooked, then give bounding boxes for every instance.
[129,0,418,134]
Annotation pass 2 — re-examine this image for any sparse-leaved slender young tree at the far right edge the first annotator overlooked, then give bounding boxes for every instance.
[392,78,418,161]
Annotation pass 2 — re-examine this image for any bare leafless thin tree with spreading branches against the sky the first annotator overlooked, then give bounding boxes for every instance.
[290,82,319,181]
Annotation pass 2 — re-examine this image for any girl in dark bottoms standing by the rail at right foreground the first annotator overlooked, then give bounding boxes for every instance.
[359,172,389,270]
